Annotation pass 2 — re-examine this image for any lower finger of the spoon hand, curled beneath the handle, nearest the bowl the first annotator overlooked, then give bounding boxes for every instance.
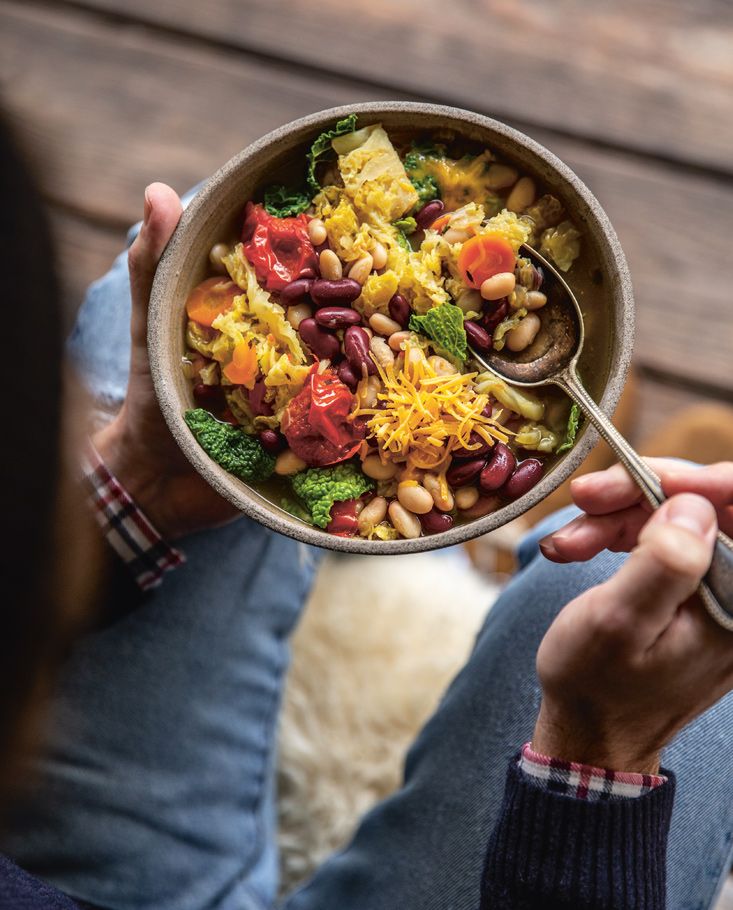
[540,506,649,562]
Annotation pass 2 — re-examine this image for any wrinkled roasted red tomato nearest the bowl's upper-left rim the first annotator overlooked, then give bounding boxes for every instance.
[242,202,318,291]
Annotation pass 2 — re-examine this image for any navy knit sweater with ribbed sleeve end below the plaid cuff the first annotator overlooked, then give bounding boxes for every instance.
[0,760,674,910]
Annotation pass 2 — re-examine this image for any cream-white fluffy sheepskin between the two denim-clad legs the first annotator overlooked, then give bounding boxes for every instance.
[278,548,499,891]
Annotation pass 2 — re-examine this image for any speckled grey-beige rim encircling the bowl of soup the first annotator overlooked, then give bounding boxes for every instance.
[148,101,634,555]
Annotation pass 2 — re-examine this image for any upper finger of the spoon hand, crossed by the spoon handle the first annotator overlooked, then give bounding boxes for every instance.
[571,458,733,515]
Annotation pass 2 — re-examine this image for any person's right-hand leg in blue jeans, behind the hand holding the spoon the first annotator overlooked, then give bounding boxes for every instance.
[284,509,733,910]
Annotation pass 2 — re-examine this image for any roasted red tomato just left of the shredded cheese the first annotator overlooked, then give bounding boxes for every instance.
[280,367,365,467]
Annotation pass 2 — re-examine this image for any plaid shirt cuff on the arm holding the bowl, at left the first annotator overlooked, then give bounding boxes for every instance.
[81,442,185,591]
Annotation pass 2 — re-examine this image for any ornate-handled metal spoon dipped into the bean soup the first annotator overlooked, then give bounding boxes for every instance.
[471,245,733,631]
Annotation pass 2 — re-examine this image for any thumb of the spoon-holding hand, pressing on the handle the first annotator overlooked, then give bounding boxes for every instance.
[603,493,717,645]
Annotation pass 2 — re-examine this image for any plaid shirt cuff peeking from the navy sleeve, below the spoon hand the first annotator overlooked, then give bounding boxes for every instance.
[519,743,667,802]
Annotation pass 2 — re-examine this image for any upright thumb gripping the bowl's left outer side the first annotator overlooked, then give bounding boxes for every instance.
[127,183,183,348]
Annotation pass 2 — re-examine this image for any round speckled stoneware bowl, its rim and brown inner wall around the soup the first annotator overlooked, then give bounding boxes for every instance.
[148,101,634,554]
